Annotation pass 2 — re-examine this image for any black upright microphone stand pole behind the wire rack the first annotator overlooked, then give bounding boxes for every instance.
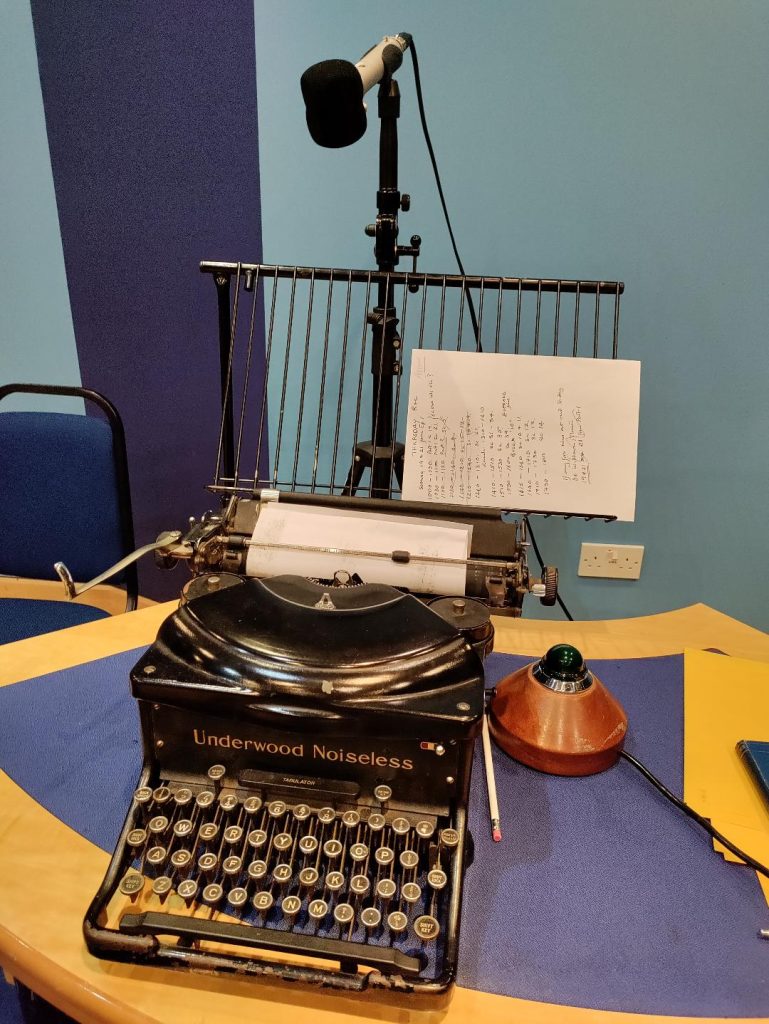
[342,74,422,498]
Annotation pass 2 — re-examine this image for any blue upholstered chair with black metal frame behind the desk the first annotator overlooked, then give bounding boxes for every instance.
[0,384,138,643]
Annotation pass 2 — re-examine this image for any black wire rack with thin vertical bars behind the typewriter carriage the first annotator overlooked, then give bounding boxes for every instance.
[201,262,624,520]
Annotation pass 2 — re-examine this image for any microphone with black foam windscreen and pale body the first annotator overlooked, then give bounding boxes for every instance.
[301,32,412,150]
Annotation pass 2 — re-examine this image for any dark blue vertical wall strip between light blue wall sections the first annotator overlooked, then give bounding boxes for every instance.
[32,0,261,596]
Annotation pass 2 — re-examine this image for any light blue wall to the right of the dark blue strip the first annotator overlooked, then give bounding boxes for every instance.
[255,0,769,629]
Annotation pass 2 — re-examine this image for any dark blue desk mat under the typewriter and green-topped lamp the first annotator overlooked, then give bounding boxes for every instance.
[0,648,769,1017]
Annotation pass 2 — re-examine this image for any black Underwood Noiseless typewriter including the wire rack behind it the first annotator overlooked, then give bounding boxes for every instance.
[75,263,621,992]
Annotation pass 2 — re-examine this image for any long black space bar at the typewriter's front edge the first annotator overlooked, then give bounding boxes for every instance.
[120,911,422,976]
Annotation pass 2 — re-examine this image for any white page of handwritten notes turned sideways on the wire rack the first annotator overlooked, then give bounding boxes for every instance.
[403,350,641,521]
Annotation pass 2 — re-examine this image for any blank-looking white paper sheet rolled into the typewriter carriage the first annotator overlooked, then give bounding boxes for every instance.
[246,501,472,594]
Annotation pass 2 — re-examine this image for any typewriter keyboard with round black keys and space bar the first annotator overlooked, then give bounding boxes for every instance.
[109,765,461,979]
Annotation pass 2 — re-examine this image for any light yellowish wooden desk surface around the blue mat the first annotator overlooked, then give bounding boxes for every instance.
[0,604,769,1024]
